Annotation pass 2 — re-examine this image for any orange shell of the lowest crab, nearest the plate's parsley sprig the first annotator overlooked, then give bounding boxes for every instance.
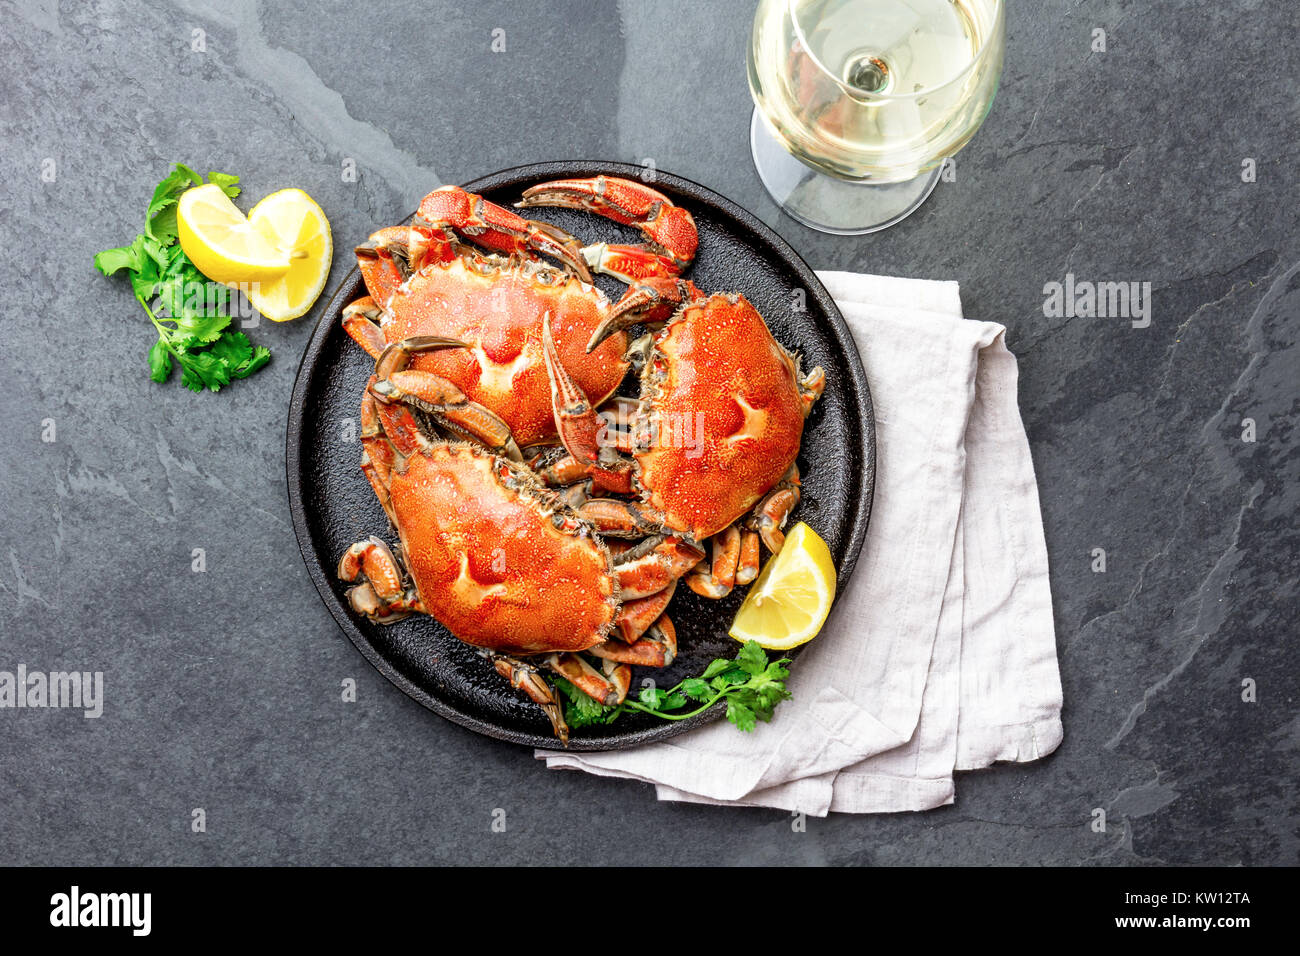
[389,442,620,654]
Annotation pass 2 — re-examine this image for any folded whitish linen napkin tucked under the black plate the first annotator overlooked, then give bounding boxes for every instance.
[536,272,1062,816]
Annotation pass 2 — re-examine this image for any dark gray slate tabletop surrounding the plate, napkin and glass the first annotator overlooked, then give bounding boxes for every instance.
[0,0,1300,864]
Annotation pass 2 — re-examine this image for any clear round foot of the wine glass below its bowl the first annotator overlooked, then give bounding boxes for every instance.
[749,109,944,235]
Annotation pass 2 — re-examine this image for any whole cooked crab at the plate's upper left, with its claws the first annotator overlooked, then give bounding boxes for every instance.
[343,177,697,446]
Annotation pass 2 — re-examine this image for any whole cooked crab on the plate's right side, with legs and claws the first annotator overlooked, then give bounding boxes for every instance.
[543,280,826,597]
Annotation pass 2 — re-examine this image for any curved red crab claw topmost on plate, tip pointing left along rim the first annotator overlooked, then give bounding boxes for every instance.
[516,176,699,276]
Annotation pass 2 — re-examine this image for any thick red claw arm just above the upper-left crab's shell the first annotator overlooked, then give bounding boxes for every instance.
[410,186,592,282]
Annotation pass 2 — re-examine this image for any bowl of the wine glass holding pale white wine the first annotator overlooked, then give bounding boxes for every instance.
[749,0,1002,183]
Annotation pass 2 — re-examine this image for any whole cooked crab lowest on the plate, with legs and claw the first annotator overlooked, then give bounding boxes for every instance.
[338,337,703,740]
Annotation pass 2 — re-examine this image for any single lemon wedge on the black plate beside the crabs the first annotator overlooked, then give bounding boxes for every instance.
[731,522,835,650]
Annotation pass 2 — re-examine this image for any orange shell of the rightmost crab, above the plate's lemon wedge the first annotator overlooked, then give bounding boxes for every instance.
[633,293,803,541]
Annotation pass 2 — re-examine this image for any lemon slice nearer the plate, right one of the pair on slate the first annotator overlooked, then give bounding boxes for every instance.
[248,189,334,323]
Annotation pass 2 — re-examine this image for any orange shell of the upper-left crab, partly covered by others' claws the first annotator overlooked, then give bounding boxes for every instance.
[381,251,628,447]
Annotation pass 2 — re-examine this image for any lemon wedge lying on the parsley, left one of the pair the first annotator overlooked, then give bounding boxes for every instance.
[176,182,290,285]
